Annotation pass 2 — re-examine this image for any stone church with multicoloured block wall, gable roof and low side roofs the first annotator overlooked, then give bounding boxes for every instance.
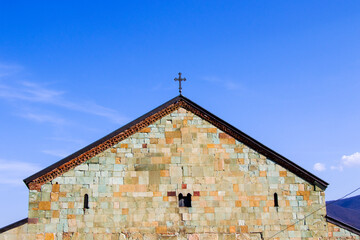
[0,94,360,240]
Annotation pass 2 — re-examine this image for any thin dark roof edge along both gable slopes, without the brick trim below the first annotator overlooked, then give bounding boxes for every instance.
[24,95,329,190]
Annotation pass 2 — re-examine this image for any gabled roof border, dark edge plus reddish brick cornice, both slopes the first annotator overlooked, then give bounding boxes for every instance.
[24,95,328,190]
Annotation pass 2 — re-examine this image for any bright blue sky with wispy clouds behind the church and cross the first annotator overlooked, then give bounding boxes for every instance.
[0,1,360,227]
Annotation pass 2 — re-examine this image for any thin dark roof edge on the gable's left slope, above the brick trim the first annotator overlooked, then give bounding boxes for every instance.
[23,95,182,186]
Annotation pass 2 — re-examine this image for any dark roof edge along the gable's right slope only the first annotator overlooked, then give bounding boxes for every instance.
[182,97,329,190]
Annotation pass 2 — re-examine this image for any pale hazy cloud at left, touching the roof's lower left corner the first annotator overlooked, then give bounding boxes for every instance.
[0,159,41,185]
